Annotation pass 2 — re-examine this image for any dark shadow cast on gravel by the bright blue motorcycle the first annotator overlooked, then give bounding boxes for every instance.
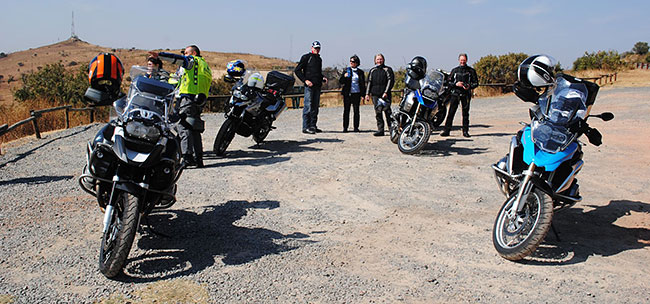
[521,200,650,266]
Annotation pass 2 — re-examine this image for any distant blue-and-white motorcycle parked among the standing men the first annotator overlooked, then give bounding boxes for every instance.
[390,70,448,154]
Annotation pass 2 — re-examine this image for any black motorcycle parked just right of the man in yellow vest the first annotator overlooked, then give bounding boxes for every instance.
[213,71,295,156]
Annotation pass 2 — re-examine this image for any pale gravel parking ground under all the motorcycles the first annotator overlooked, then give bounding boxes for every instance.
[0,87,650,303]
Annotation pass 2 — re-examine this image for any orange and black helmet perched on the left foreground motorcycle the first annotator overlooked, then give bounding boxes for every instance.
[88,53,124,96]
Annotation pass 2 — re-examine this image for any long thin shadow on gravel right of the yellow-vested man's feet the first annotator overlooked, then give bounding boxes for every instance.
[203,138,343,168]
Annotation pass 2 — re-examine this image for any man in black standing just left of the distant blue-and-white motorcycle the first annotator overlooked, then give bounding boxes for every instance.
[366,54,395,136]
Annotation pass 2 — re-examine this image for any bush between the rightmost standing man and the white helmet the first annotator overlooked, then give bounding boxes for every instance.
[474,53,528,84]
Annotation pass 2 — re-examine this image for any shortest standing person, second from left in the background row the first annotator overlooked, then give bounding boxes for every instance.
[339,55,366,133]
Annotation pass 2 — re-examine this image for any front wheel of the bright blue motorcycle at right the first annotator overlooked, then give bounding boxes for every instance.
[492,189,553,261]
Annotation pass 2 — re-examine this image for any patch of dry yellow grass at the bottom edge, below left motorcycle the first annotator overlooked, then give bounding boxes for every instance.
[99,279,210,304]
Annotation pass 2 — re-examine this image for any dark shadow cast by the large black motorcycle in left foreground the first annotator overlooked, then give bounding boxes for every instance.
[118,201,313,283]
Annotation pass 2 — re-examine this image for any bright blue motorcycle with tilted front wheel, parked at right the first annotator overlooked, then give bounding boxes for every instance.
[492,74,614,261]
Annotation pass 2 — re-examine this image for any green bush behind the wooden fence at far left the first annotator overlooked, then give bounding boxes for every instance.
[13,63,88,105]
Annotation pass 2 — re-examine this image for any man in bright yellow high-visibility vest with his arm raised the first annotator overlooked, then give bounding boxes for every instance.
[149,45,212,168]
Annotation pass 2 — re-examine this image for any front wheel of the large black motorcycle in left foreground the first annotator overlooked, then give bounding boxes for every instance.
[99,192,139,278]
